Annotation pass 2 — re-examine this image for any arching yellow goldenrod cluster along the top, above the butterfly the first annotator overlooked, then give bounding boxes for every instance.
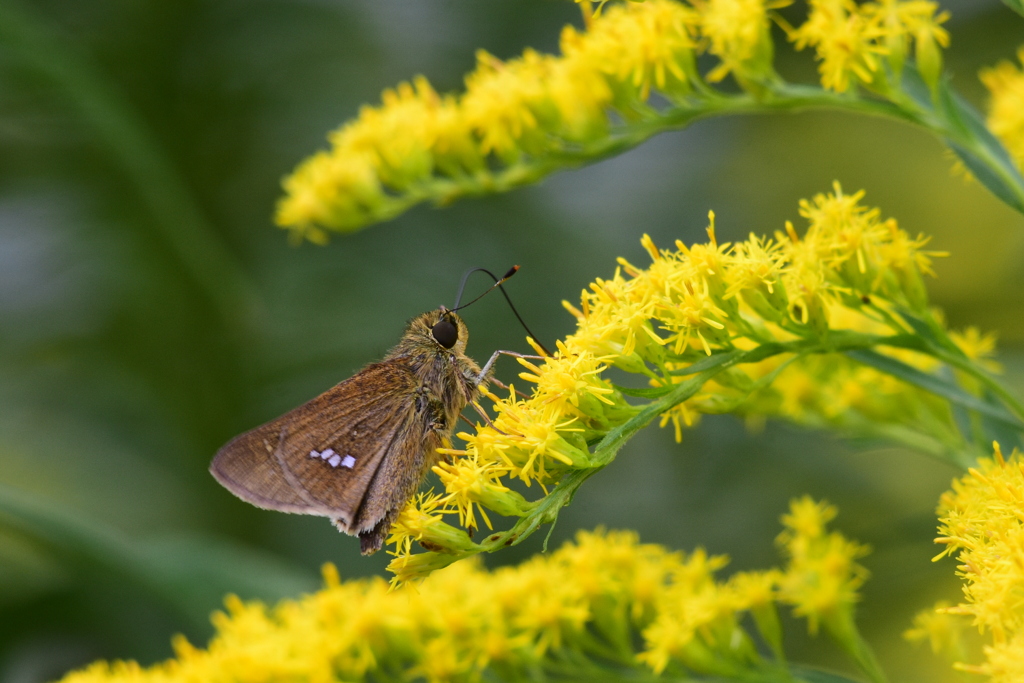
[276,0,947,243]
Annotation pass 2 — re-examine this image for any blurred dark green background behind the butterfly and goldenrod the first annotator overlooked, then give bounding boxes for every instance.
[0,0,1024,683]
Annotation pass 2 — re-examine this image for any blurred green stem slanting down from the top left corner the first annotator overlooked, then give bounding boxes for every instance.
[0,0,259,324]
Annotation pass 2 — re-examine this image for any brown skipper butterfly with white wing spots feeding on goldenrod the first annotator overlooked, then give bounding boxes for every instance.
[210,266,529,555]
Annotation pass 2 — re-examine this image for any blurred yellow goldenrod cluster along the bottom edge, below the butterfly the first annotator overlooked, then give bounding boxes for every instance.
[63,501,863,683]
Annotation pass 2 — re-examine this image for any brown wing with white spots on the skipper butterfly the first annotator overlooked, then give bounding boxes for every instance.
[210,359,423,533]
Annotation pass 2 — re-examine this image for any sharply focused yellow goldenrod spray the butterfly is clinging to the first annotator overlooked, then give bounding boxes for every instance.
[389,184,991,582]
